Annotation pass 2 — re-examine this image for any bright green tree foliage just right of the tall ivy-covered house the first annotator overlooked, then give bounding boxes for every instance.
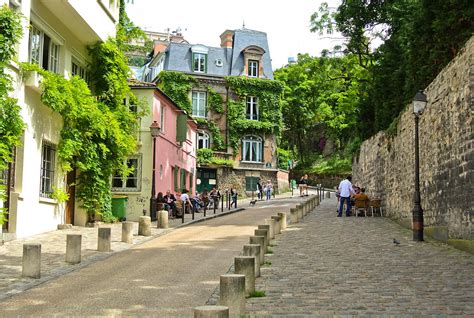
[275,54,368,163]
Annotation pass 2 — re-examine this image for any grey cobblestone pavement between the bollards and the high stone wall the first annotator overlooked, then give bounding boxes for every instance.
[247,199,474,317]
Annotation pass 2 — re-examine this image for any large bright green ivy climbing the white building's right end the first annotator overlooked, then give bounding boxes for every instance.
[22,40,138,221]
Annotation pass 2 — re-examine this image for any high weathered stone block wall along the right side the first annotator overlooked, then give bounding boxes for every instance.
[353,37,474,240]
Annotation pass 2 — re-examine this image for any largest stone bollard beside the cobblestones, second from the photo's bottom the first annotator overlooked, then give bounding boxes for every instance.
[219,274,245,317]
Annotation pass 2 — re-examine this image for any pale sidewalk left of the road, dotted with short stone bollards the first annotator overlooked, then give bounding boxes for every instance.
[0,193,291,301]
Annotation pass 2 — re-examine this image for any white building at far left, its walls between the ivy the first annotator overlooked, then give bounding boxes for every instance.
[0,0,119,239]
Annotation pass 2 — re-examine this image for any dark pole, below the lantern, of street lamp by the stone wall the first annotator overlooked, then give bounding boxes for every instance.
[412,115,423,242]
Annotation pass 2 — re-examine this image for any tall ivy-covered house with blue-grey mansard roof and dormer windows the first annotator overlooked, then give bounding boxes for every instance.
[142,28,281,195]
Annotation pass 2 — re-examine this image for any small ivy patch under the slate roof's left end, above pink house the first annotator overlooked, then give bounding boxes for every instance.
[158,71,196,114]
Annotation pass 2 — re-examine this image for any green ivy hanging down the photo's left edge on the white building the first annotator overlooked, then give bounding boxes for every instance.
[0,5,25,225]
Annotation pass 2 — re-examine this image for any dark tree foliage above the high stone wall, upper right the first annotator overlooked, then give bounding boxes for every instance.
[312,0,474,138]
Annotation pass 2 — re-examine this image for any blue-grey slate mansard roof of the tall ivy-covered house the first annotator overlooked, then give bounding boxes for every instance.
[164,29,273,79]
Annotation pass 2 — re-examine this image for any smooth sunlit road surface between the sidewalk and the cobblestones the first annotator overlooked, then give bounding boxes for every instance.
[0,198,299,317]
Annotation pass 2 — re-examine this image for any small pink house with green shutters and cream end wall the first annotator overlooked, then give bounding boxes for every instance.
[112,80,197,221]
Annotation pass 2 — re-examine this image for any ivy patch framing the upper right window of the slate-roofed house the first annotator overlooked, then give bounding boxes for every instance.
[226,76,283,151]
